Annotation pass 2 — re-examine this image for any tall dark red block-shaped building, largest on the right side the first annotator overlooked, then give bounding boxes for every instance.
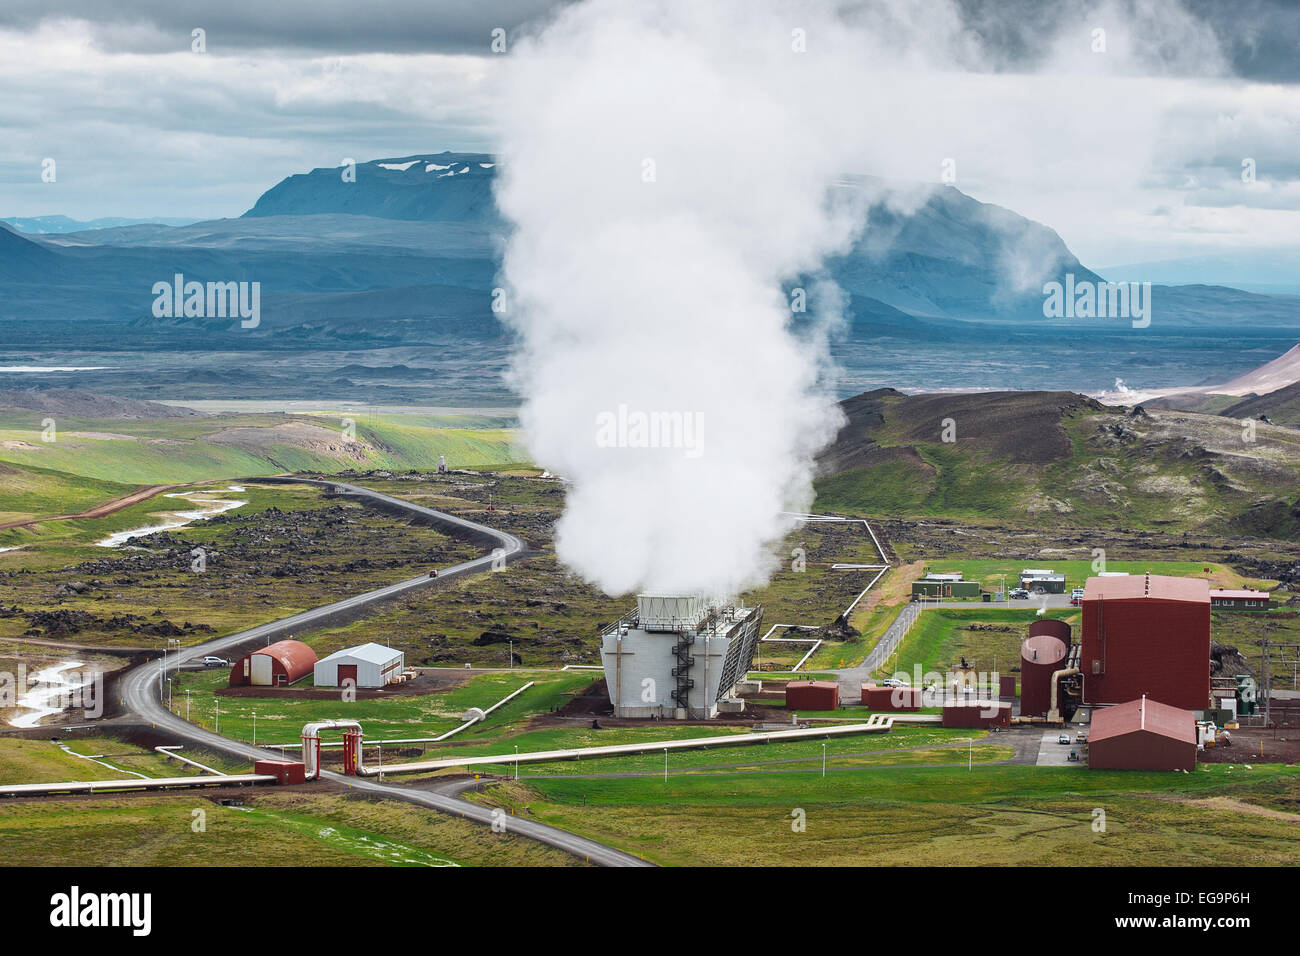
[1079,574,1210,710]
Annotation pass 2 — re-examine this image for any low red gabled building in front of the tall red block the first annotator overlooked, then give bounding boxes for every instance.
[1088,697,1196,770]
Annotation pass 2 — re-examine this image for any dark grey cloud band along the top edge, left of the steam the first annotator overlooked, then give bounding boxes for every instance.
[0,0,574,53]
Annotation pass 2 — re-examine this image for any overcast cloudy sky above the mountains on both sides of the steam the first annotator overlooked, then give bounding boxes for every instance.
[0,0,1300,268]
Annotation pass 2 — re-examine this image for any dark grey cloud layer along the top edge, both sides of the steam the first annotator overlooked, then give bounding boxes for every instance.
[0,0,1300,83]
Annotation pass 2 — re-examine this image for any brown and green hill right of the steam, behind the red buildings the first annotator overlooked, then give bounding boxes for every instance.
[818,389,1300,537]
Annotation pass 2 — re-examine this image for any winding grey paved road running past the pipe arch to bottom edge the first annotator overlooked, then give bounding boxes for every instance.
[120,479,649,866]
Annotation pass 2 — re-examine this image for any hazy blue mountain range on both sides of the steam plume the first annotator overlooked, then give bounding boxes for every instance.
[0,151,1300,403]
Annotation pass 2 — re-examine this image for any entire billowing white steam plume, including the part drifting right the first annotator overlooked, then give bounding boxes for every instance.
[497,0,1227,597]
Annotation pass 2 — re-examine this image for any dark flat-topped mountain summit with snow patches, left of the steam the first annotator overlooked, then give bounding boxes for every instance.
[244,152,499,224]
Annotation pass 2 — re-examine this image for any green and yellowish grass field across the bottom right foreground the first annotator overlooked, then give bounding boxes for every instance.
[481,763,1300,868]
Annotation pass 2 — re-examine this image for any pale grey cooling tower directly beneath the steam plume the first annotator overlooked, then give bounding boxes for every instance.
[601,594,763,721]
